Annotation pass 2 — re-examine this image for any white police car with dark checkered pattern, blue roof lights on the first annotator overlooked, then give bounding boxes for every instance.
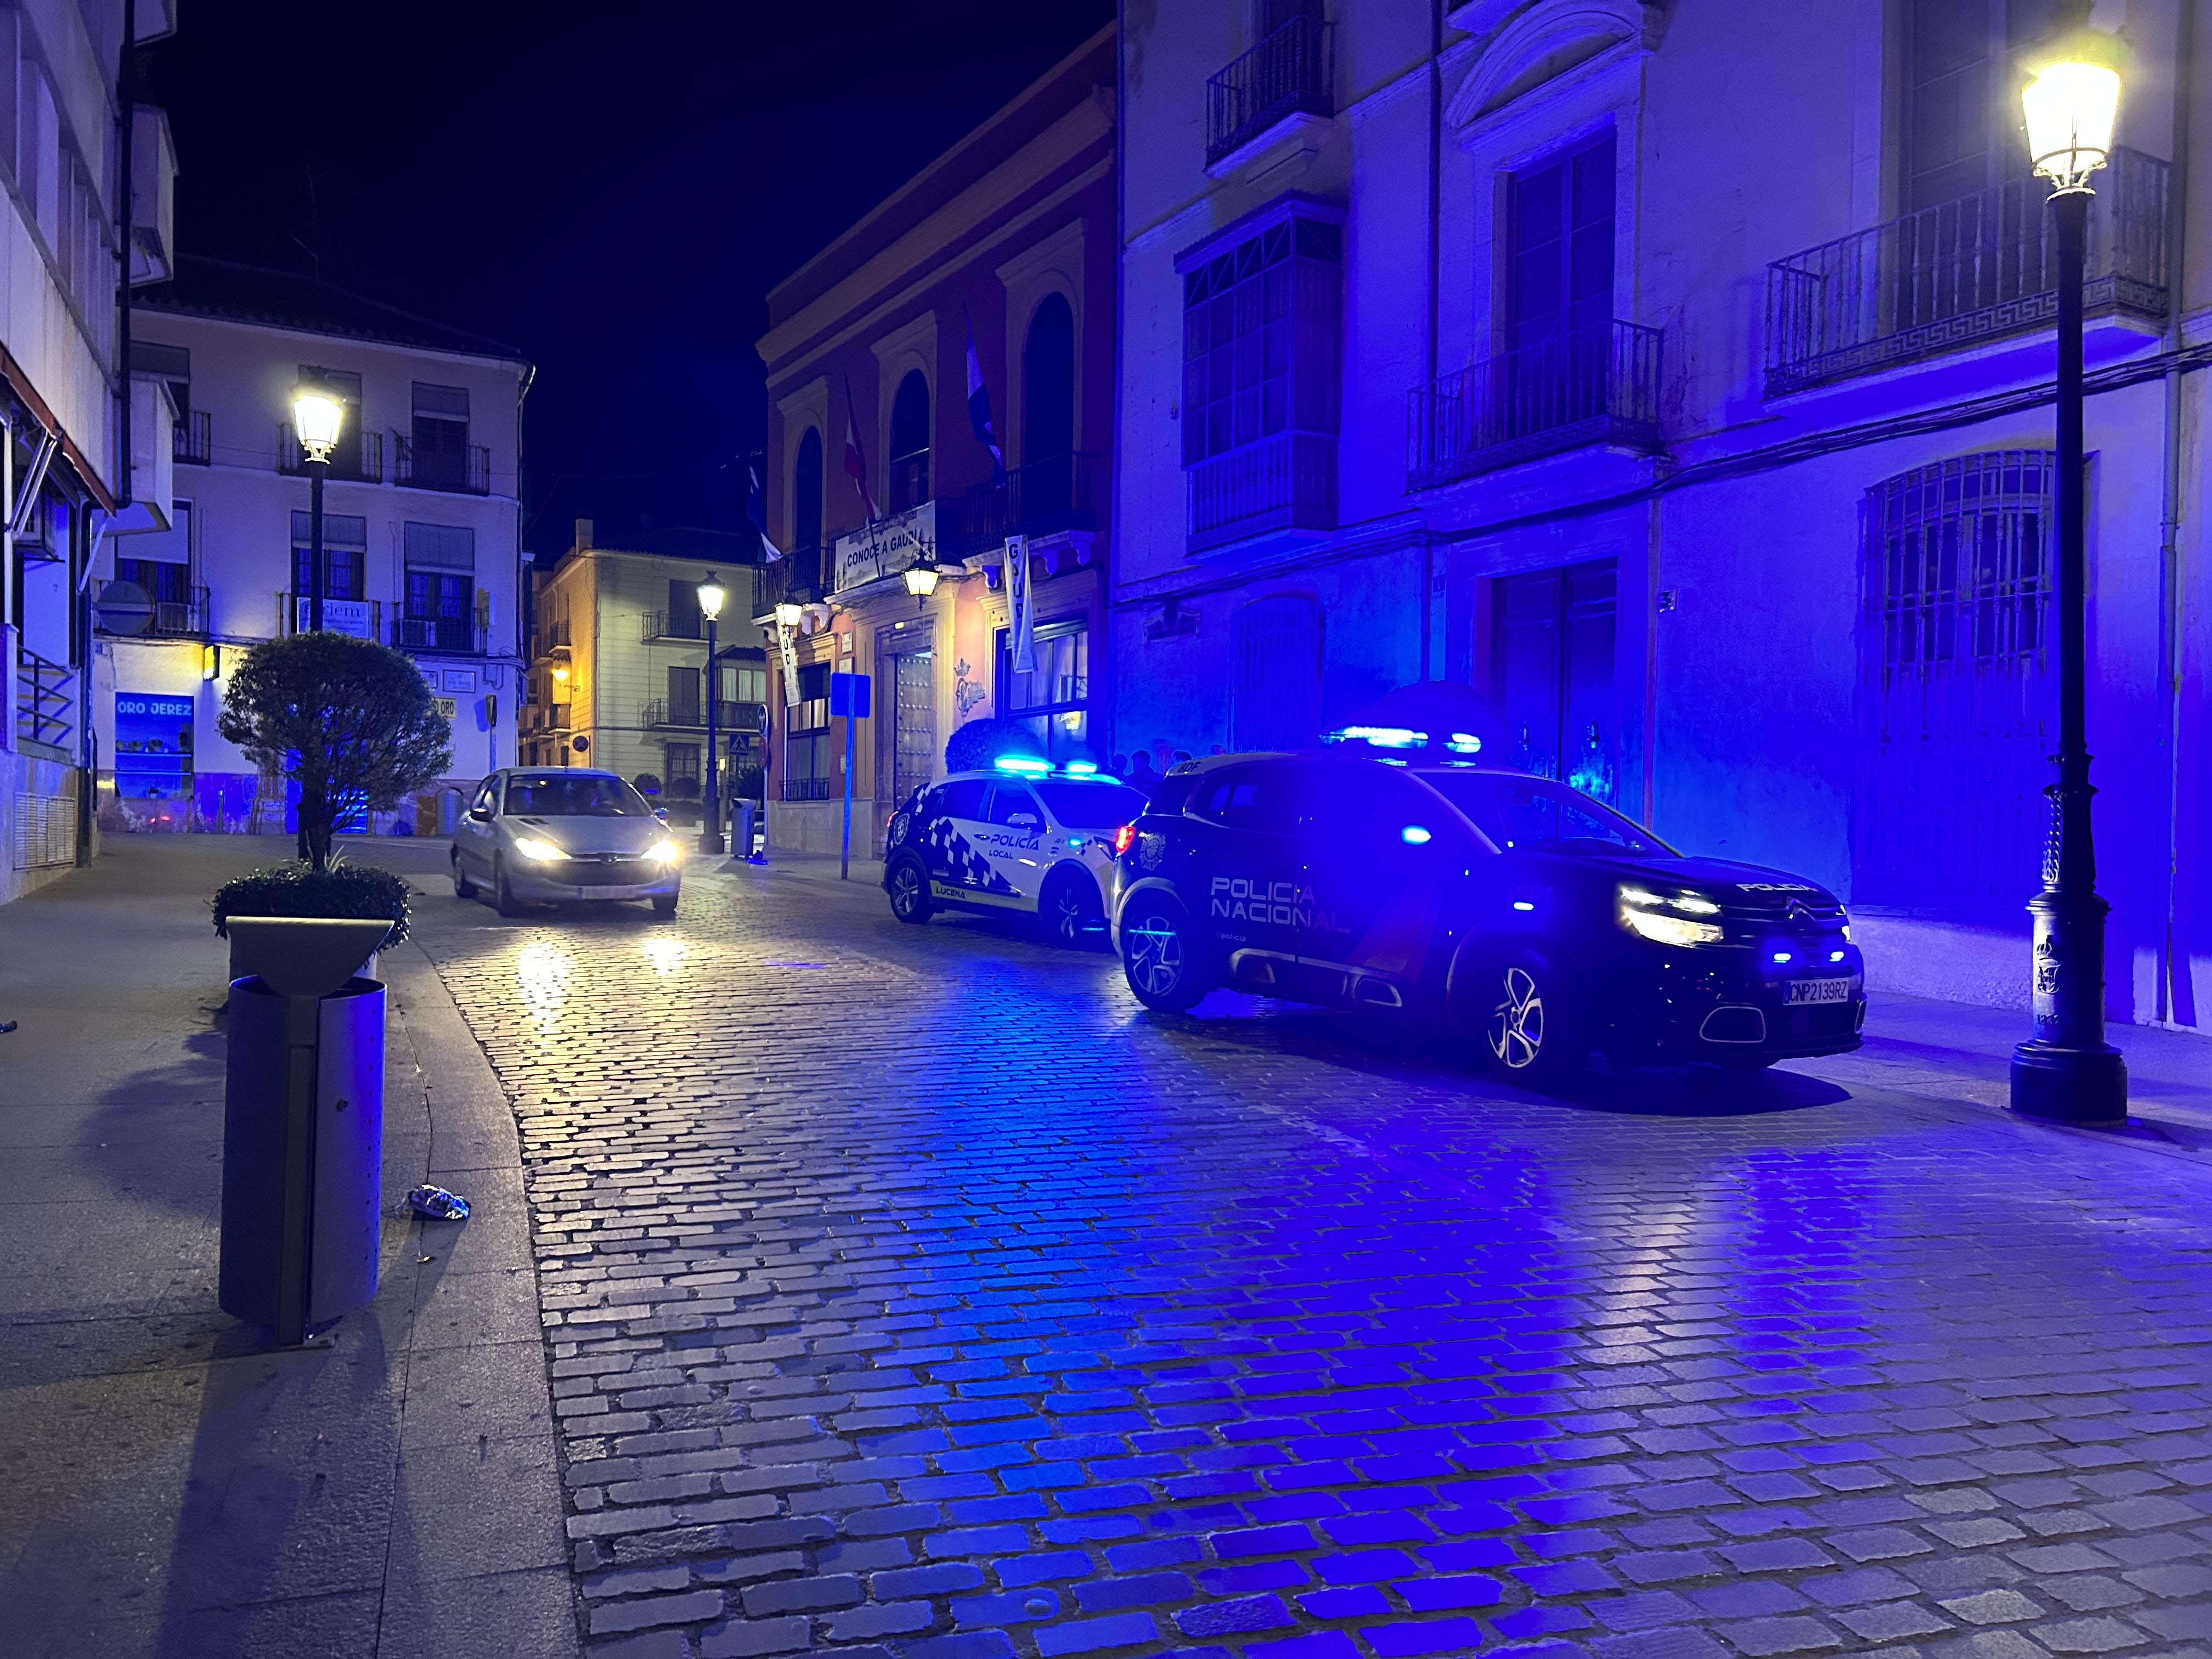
[883,757,1144,945]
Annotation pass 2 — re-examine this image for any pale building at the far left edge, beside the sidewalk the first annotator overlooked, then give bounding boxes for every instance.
[0,0,177,902]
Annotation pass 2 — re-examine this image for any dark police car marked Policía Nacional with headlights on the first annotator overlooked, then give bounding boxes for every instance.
[1113,747,1867,1084]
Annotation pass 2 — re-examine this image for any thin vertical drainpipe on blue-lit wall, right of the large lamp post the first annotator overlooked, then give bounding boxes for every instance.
[2154,4,2197,1024]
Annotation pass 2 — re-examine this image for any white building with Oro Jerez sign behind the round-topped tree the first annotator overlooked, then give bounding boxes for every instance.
[93,259,529,834]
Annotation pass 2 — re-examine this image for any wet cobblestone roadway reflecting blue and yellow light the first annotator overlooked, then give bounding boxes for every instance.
[418,872,2212,1659]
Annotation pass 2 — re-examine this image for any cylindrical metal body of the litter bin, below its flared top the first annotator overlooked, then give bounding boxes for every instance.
[217,975,385,1342]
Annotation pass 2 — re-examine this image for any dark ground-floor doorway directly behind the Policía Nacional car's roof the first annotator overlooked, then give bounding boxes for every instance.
[1484,560,1621,801]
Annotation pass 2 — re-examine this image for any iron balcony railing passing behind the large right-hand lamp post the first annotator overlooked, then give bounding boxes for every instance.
[1768,150,2168,394]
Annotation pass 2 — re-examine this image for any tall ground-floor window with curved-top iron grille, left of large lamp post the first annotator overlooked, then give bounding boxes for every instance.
[1852,449,2055,916]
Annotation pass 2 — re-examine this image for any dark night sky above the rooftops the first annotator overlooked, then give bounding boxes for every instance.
[146,0,1113,551]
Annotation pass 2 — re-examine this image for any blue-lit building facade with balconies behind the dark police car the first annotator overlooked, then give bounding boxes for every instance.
[1110,0,2212,1026]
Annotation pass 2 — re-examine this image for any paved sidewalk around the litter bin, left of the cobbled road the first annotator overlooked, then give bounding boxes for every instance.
[0,836,577,1659]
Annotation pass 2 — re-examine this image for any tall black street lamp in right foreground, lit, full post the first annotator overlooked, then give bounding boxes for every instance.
[2013,31,2128,1124]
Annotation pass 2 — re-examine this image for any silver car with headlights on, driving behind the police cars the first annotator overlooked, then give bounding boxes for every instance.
[454,765,684,916]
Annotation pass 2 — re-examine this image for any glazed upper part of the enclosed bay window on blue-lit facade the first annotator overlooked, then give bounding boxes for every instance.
[1181,215,1342,467]
